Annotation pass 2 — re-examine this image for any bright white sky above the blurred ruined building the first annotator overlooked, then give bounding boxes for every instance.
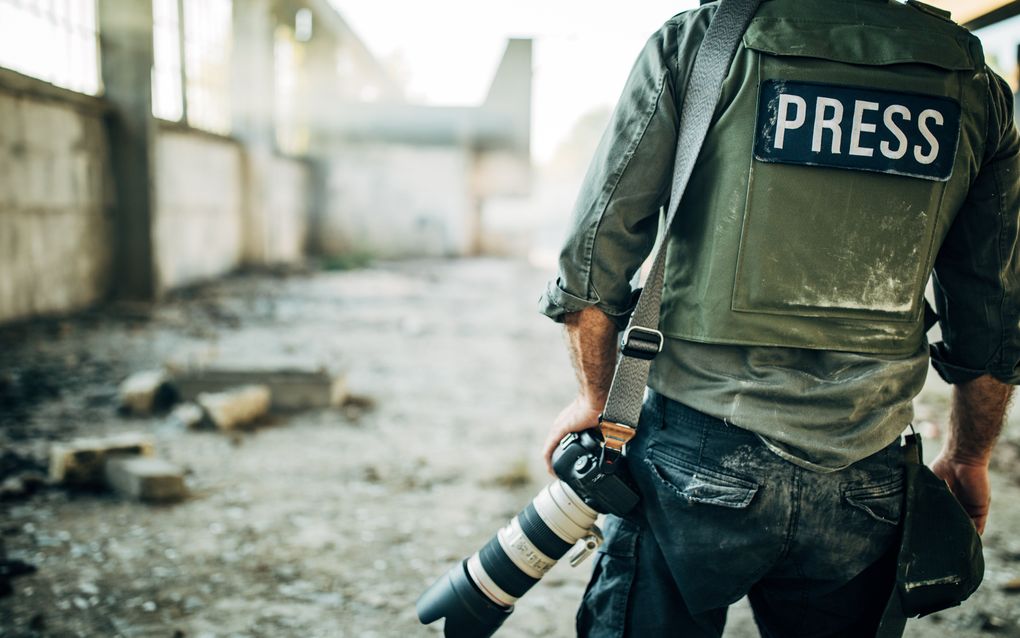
[330,0,698,162]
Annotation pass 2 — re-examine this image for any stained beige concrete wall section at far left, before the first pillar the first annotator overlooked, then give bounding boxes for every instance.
[0,85,112,322]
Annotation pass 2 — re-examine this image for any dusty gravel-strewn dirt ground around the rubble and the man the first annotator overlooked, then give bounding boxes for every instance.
[0,259,1020,638]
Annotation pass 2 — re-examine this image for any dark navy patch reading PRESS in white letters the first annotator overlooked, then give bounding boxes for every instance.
[755,80,960,182]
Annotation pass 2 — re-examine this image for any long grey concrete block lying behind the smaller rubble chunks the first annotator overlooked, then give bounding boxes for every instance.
[169,365,347,412]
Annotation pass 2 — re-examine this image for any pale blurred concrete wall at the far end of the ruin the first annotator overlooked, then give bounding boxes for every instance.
[315,144,475,257]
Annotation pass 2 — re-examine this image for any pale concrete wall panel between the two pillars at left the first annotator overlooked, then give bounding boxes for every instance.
[153,127,245,291]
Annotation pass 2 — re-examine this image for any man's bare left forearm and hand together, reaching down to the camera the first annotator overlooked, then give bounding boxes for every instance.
[543,306,617,474]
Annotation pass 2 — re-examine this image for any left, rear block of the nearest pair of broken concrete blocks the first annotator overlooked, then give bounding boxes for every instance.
[50,433,153,487]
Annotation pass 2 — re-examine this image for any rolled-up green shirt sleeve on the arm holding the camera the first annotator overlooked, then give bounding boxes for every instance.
[539,11,697,327]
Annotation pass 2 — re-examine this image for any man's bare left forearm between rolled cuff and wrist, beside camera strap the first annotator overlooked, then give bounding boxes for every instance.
[565,307,618,409]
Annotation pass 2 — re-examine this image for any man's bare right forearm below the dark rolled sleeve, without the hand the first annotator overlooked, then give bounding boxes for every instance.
[945,376,1013,464]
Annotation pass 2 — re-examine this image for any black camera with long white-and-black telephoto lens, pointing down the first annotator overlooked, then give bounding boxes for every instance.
[417,432,638,638]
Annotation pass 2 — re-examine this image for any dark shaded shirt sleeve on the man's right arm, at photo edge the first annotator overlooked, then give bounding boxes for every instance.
[931,71,1020,385]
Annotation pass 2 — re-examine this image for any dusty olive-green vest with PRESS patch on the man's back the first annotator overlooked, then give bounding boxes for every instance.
[662,0,988,355]
